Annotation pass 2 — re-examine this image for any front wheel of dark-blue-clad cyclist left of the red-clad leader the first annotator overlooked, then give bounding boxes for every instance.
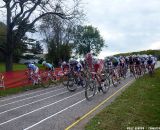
[67,75,77,92]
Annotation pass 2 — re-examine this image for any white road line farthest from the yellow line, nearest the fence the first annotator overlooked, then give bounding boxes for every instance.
[0,88,62,102]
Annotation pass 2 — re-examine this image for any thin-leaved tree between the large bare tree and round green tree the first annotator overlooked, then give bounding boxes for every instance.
[40,9,83,65]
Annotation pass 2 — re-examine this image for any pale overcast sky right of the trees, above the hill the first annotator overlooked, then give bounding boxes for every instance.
[84,0,160,58]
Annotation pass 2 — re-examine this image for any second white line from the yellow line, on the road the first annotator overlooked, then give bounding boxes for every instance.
[0,90,84,126]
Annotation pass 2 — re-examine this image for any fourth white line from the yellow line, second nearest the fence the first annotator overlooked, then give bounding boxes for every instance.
[0,89,66,107]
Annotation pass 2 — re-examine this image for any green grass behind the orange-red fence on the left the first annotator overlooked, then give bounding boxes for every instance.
[0,63,43,72]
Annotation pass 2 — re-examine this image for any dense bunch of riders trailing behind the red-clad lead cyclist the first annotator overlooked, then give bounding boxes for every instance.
[106,55,157,75]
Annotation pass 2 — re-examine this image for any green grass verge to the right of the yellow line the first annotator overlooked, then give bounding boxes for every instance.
[85,69,160,130]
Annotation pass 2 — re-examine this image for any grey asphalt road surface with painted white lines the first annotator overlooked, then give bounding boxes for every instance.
[0,62,159,130]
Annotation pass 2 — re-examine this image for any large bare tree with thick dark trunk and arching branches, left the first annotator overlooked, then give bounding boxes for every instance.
[0,0,84,71]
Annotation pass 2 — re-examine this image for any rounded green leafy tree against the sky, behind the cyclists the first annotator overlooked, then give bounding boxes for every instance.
[73,26,104,55]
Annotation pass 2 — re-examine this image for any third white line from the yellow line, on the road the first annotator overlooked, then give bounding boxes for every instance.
[0,91,68,115]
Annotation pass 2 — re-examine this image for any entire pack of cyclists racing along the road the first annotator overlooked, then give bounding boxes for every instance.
[24,53,157,90]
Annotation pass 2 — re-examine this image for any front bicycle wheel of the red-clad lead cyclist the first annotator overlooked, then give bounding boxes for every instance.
[85,80,96,100]
